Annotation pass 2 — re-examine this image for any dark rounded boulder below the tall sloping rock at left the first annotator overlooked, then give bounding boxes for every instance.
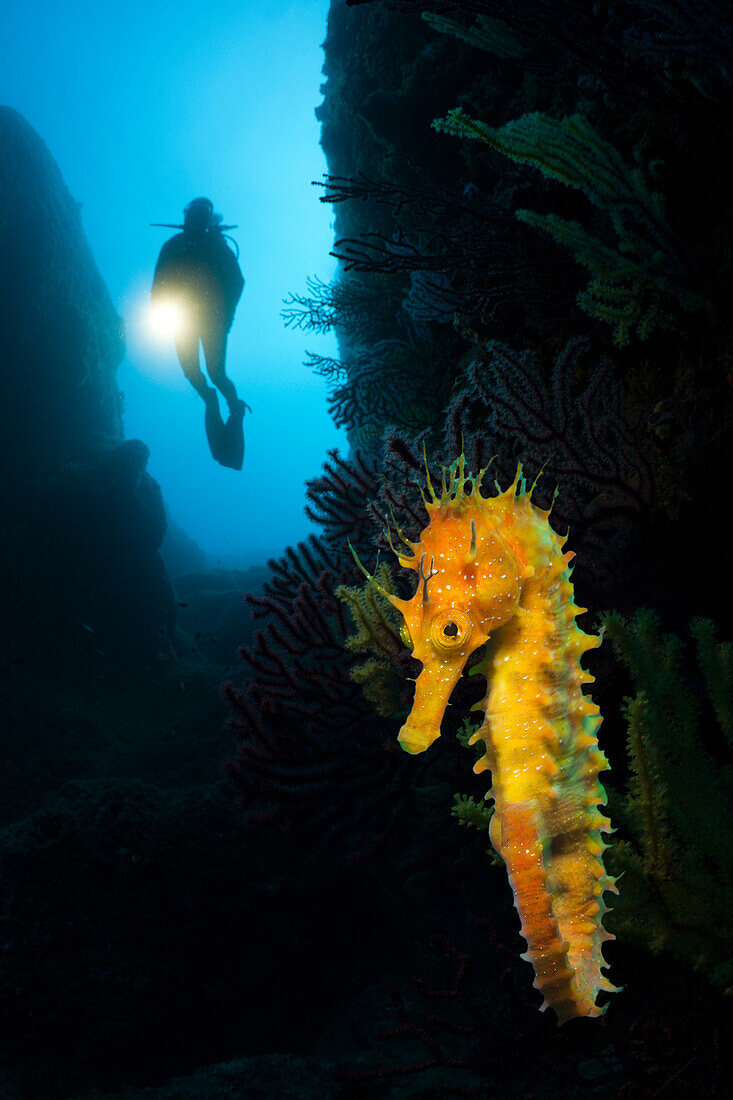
[13,439,175,661]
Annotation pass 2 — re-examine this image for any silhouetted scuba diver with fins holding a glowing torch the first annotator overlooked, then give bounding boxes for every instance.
[151,198,251,470]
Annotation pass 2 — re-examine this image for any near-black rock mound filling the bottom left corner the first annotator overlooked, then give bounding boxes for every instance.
[0,779,326,1100]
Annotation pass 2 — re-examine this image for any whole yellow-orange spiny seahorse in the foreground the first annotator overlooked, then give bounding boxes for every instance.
[360,454,617,1023]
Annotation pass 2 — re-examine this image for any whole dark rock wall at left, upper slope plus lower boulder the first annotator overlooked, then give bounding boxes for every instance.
[0,107,175,660]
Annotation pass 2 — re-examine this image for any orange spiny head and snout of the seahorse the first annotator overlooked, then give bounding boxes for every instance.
[390,455,527,752]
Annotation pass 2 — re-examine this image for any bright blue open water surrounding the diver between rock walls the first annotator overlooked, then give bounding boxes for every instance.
[0,0,347,564]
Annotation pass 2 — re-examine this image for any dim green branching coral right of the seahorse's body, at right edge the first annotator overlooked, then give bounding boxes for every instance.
[603,611,733,987]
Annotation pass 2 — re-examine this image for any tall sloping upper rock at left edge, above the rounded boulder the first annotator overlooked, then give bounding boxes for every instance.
[0,107,124,481]
